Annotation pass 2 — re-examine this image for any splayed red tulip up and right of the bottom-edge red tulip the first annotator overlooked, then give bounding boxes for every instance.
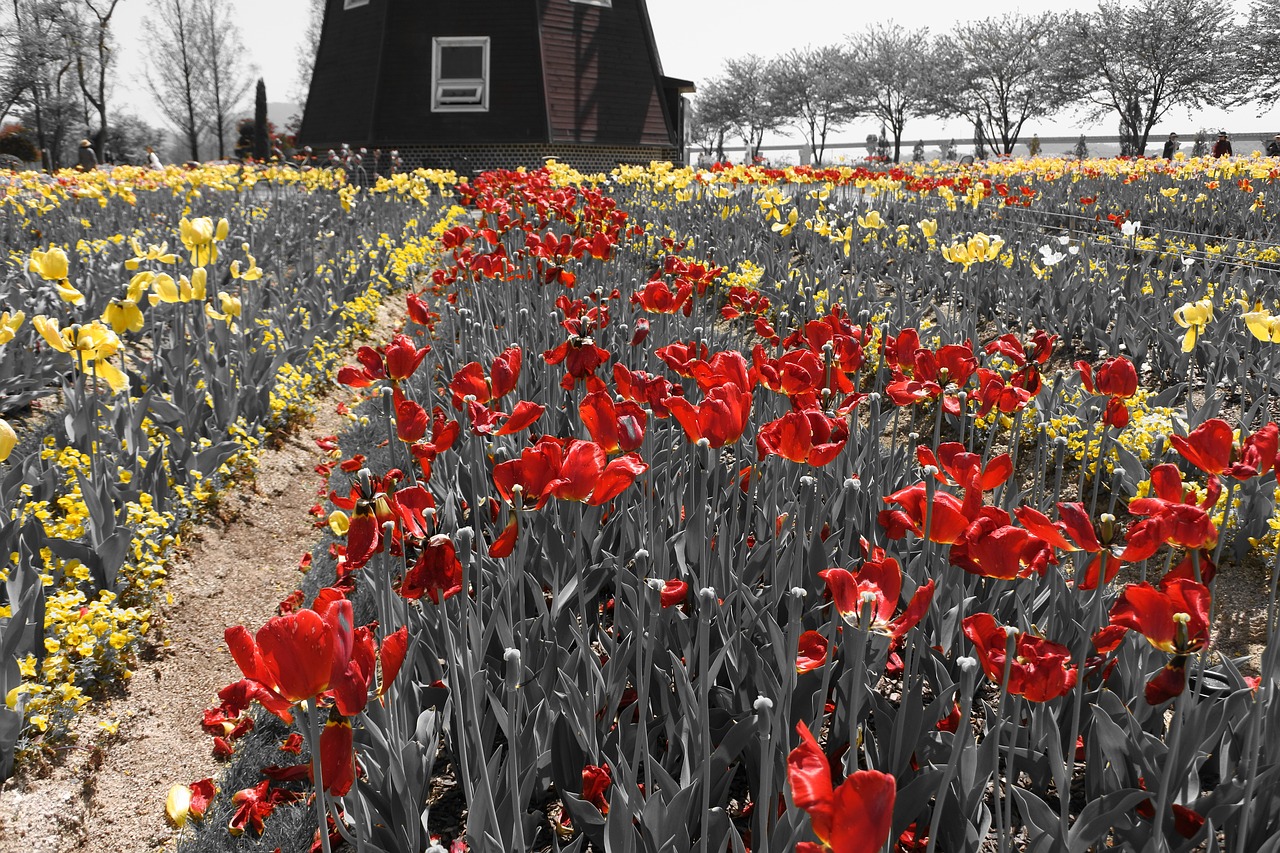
[961,613,1078,702]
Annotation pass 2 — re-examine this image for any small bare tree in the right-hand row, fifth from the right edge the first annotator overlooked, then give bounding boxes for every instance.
[769,45,859,164]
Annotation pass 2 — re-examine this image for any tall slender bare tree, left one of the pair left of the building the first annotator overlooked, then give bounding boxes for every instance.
[143,0,207,160]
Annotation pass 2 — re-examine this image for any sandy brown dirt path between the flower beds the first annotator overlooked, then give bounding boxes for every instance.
[0,295,404,853]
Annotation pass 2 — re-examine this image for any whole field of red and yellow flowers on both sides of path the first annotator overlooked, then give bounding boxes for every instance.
[0,159,1280,853]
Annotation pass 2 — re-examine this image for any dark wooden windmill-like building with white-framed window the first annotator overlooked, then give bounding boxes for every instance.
[298,0,692,173]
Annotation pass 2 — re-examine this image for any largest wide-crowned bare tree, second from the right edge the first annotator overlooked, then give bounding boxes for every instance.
[1057,0,1239,155]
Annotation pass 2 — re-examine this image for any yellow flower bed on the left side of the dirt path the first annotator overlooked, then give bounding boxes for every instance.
[0,162,460,772]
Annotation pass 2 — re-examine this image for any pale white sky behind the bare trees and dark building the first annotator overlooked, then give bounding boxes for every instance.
[115,0,1280,151]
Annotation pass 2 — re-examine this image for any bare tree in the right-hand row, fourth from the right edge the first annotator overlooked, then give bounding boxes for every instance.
[845,20,941,163]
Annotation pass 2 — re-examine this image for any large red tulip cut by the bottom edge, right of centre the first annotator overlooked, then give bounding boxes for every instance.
[787,722,897,853]
